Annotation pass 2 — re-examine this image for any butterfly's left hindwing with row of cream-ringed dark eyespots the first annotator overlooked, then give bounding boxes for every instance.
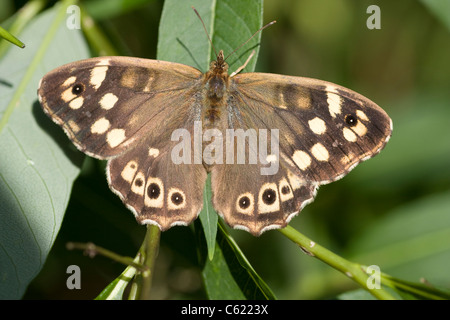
[107,126,206,230]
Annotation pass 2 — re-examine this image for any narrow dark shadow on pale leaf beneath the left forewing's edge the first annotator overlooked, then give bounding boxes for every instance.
[32,100,84,168]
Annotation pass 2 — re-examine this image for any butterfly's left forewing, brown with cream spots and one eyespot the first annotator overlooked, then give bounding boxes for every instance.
[38,57,201,159]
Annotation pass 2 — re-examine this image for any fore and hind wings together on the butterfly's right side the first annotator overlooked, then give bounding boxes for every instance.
[211,73,392,235]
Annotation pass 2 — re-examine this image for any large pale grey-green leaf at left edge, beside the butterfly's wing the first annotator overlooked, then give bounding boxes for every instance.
[0,1,88,299]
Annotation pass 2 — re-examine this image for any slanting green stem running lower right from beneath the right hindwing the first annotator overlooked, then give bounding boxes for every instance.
[279,226,394,300]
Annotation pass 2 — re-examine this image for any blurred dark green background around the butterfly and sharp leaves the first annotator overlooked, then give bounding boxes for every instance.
[0,0,450,299]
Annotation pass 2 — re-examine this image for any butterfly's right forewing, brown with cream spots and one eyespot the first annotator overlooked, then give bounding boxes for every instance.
[234,73,392,184]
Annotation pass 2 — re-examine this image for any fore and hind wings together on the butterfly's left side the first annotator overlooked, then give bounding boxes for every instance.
[38,57,206,230]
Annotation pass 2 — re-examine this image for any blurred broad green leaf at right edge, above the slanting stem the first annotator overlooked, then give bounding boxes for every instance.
[350,191,450,284]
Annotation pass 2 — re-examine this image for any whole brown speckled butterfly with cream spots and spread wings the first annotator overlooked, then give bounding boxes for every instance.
[38,26,392,235]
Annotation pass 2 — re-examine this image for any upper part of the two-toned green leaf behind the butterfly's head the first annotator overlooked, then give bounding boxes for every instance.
[157,0,262,73]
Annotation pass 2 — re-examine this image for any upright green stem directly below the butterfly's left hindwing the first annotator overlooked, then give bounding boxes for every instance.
[137,225,161,300]
